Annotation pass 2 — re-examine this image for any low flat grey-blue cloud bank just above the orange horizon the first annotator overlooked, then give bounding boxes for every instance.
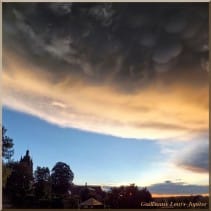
[148,181,209,194]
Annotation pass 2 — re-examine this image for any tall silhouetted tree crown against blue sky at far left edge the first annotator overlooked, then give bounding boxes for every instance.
[2,126,14,161]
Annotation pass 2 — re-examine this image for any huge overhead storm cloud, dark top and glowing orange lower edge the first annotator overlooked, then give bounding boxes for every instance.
[3,3,208,140]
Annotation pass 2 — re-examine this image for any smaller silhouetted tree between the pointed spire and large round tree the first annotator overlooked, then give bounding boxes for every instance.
[34,166,51,203]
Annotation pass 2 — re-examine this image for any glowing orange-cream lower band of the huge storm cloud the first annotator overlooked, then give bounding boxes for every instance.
[2,50,209,140]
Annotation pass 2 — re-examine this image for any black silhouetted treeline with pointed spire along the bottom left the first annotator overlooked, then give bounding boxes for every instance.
[2,127,152,208]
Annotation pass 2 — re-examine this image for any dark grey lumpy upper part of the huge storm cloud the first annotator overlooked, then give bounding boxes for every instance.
[3,3,208,90]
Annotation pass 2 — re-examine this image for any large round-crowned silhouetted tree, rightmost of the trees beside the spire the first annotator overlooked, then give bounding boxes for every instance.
[51,162,74,197]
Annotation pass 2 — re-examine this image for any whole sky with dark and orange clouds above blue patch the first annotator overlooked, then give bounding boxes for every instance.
[2,3,209,194]
